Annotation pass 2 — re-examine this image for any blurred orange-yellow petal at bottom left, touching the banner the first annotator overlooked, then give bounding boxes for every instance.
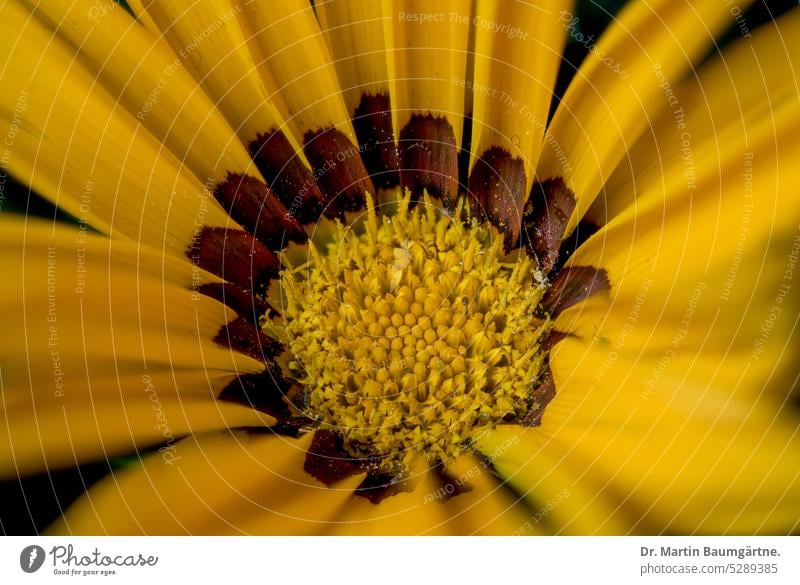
[49,432,360,535]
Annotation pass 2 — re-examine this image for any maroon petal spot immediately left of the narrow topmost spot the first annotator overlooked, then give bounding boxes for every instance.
[303,128,375,216]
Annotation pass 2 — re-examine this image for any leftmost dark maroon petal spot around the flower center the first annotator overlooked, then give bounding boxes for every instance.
[186,227,280,291]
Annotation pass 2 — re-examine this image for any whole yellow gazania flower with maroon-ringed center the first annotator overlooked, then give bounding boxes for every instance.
[0,0,800,534]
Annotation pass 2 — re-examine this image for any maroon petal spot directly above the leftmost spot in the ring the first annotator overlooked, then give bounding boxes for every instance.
[214,174,308,250]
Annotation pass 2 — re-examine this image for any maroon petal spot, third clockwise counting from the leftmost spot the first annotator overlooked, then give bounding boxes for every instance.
[248,128,325,224]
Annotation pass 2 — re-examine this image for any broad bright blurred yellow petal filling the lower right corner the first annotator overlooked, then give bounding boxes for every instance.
[540,339,800,534]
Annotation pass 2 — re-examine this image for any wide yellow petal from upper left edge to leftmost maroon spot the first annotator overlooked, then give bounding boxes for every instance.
[0,4,235,256]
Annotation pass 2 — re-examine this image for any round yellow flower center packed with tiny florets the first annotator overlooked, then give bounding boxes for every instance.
[262,196,550,471]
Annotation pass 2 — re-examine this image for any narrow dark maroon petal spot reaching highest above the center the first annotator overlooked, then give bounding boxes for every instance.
[353,93,400,189]
